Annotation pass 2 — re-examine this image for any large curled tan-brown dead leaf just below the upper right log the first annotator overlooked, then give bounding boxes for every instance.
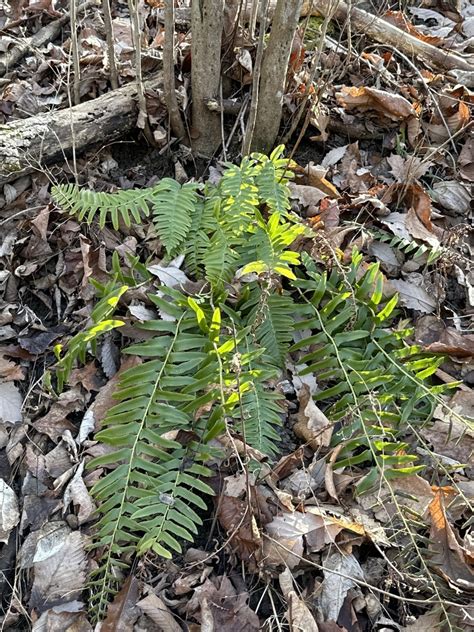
[336,86,416,121]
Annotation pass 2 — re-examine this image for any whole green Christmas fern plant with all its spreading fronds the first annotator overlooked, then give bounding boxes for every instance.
[49,148,462,619]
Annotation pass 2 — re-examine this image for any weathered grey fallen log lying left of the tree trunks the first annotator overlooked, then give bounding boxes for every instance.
[0,73,162,186]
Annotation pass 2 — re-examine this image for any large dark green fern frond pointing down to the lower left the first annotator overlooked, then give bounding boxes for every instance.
[89,312,212,618]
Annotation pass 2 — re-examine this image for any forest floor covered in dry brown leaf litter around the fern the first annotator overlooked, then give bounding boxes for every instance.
[0,0,474,632]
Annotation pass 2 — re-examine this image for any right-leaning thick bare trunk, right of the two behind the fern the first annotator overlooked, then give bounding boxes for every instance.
[252,0,302,153]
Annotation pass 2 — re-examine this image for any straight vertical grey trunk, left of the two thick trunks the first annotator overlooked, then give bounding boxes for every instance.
[191,0,224,156]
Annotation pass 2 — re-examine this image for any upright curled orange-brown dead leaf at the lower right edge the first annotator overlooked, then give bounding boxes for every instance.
[428,489,474,592]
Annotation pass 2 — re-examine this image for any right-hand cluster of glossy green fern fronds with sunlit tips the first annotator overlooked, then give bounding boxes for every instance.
[290,254,447,492]
